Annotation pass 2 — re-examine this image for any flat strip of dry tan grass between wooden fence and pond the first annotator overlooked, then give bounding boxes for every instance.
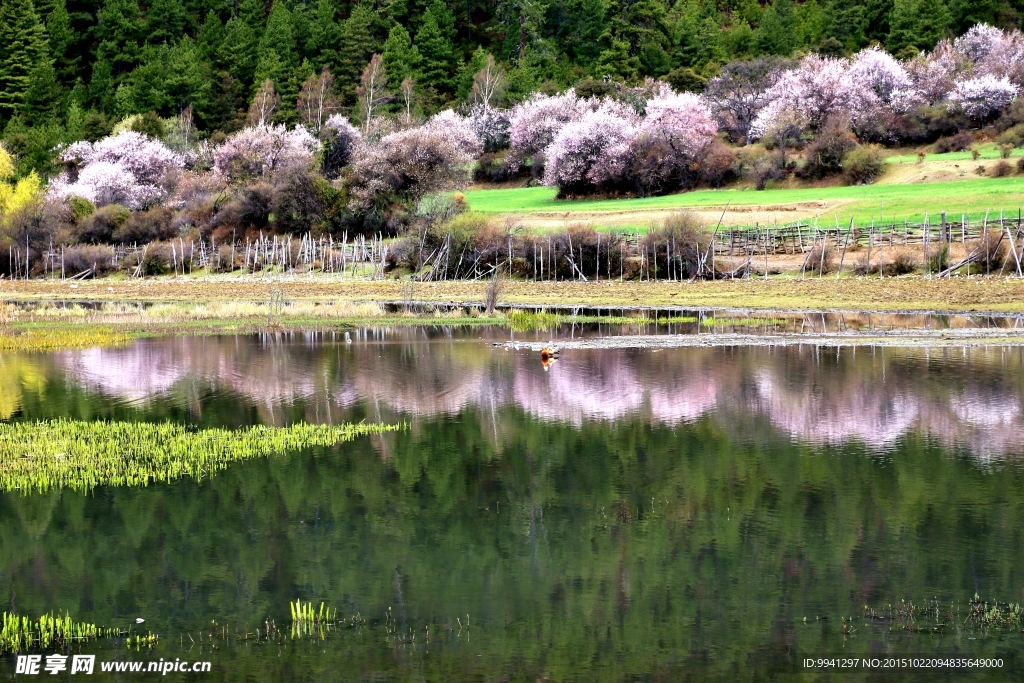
[0,275,1024,315]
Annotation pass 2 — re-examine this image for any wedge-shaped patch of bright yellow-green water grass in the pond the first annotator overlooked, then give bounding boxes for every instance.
[0,418,401,493]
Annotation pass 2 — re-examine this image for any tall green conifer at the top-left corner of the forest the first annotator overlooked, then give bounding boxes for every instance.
[0,0,49,117]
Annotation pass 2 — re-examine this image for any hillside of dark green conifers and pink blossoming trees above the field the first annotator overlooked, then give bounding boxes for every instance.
[0,0,1024,274]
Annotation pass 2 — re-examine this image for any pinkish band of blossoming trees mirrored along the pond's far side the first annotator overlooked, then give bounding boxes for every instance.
[0,330,1024,457]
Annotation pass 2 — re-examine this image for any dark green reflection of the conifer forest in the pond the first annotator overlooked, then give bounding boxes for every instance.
[0,405,1024,682]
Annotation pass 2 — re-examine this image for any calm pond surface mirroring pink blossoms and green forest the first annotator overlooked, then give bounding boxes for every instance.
[0,328,1024,683]
